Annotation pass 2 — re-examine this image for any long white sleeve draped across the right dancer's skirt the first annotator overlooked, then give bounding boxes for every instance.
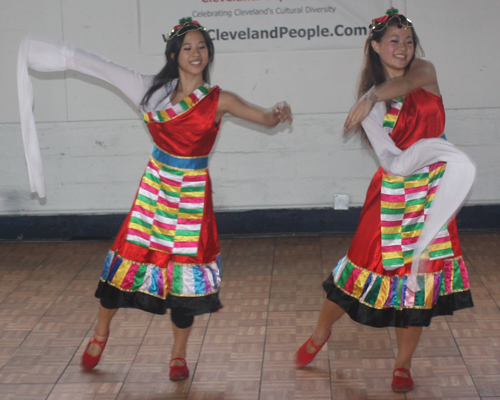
[361,102,476,292]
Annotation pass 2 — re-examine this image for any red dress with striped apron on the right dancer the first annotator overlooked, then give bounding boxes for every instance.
[323,89,473,327]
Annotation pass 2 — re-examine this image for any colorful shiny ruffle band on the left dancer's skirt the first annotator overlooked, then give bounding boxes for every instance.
[101,251,220,299]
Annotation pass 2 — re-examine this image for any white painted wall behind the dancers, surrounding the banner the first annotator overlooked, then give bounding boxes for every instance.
[0,0,500,215]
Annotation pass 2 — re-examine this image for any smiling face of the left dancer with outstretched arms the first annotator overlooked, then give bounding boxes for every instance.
[177,30,208,75]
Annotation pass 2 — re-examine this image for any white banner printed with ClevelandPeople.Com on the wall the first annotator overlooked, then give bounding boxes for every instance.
[138,0,391,55]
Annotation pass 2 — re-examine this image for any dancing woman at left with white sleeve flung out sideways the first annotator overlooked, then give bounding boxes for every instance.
[18,19,292,380]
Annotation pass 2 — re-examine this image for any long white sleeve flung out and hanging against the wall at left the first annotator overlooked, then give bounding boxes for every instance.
[17,38,152,198]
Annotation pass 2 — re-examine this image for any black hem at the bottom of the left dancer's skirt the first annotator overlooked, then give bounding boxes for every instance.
[95,281,223,316]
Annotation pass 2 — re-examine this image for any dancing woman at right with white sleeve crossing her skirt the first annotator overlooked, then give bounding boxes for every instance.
[295,9,475,392]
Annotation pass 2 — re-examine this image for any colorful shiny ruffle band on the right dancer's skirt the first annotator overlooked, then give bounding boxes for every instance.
[333,257,470,310]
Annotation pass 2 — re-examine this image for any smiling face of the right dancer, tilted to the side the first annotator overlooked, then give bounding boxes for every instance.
[371,26,415,78]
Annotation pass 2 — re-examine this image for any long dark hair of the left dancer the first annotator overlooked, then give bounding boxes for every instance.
[141,24,214,107]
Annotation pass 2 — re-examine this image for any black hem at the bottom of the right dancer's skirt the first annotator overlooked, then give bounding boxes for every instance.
[323,274,474,328]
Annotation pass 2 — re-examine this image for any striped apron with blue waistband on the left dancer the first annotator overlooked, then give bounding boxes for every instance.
[127,148,208,256]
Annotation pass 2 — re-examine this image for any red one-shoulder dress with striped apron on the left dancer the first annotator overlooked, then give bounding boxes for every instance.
[96,86,222,315]
